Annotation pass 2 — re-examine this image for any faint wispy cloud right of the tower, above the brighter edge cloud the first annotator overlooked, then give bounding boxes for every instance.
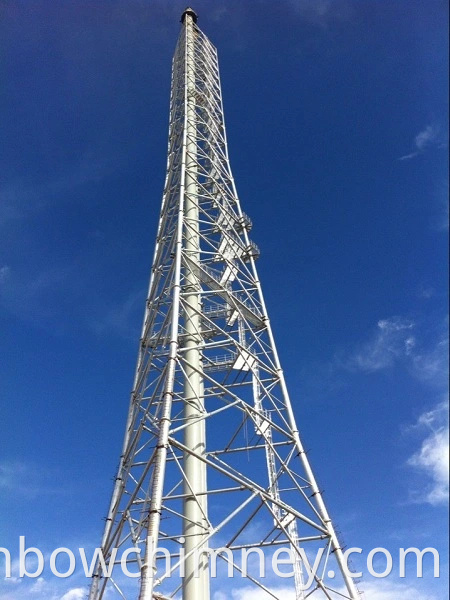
[341,317,416,373]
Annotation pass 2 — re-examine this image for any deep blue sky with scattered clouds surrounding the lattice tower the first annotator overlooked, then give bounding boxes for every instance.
[0,0,448,600]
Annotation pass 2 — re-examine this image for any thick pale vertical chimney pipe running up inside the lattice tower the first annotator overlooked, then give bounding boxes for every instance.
[183,9,210,600]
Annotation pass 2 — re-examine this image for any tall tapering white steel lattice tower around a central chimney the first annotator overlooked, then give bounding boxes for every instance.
[89,8,359,600]
